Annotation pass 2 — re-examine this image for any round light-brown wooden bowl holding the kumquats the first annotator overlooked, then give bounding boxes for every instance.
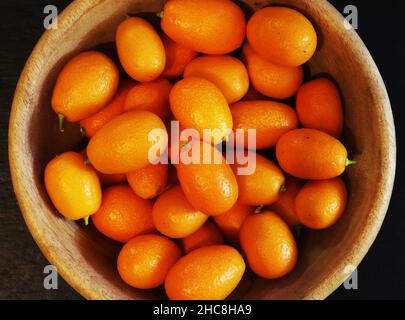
[9,0,396,299]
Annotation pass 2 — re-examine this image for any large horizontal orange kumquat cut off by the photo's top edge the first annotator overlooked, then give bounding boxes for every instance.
[161,0,246,54]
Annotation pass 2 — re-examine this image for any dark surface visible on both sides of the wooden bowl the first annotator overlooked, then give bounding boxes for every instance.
[0,0,405,299]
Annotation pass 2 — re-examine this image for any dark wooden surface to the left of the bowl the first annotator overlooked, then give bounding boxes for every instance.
[0,0,81,299]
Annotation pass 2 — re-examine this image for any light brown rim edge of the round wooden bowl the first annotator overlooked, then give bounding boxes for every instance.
[8,0,396,300]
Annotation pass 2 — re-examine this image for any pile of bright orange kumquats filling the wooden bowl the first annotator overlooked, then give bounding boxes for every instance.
[44,0,354,299]
